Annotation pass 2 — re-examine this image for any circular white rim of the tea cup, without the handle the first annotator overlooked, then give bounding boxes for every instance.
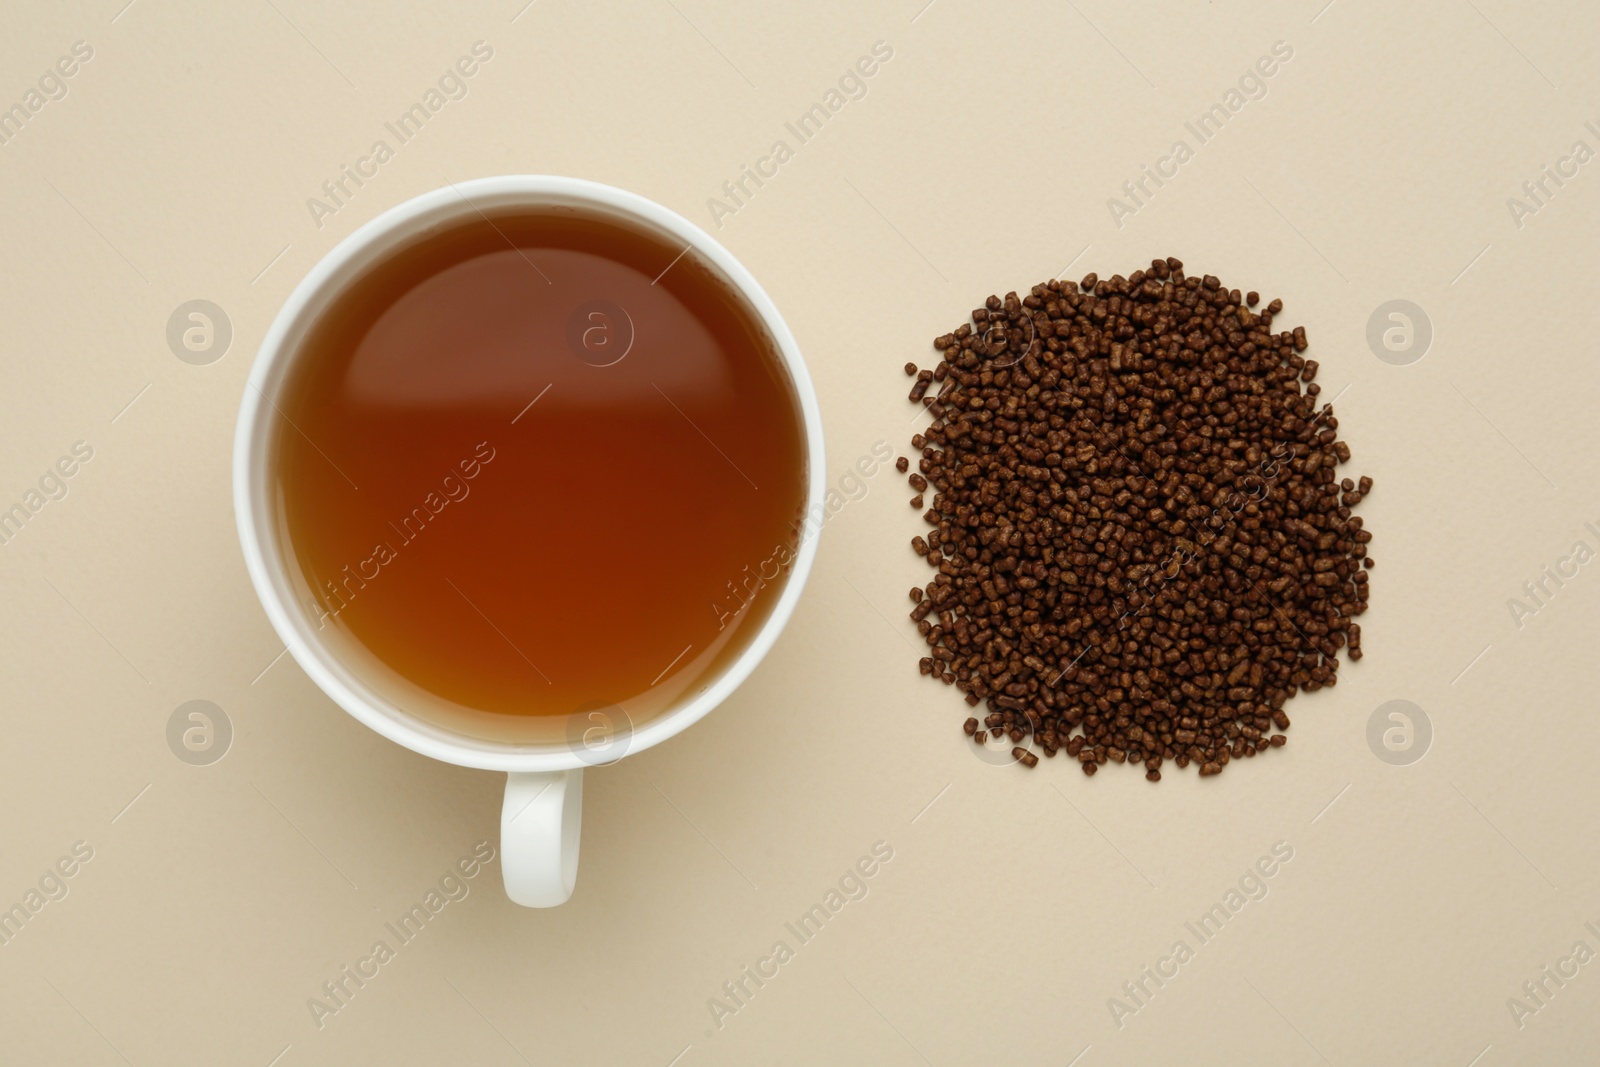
[234,174,826,771]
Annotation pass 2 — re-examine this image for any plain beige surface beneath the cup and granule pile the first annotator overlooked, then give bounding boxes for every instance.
[0,0,1600,1067]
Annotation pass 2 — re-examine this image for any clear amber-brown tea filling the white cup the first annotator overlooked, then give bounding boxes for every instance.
[274,213,808,741]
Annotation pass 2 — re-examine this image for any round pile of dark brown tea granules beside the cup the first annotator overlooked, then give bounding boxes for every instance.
[899,259,1373,782]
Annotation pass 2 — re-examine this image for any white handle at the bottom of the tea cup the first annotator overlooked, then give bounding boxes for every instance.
[501,768,584,907]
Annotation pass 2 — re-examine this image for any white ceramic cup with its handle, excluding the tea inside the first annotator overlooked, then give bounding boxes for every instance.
[234,174,824,907]
